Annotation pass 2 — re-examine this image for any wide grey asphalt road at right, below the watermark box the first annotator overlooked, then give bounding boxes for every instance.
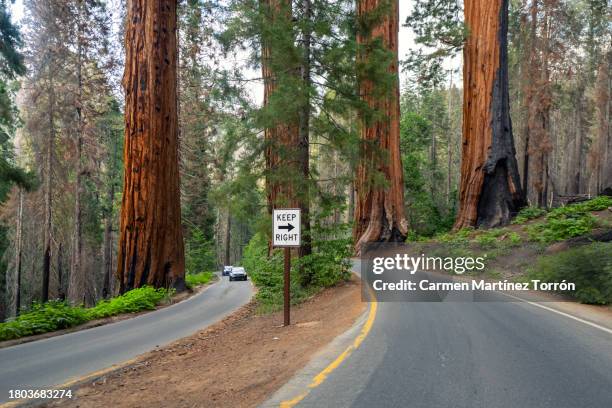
[298,264,612,408]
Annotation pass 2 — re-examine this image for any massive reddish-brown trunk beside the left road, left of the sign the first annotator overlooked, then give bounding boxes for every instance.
[117,0,185,292]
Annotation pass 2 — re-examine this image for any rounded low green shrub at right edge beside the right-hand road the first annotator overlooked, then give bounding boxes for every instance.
[527,242,612,304]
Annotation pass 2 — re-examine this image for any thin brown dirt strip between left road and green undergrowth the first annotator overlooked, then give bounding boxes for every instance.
[0,275,219,349]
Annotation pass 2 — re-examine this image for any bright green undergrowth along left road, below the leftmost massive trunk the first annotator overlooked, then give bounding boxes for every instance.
[0,286,174,341]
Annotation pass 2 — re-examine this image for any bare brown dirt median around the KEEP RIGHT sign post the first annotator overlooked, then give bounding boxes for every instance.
[41,279,367,408]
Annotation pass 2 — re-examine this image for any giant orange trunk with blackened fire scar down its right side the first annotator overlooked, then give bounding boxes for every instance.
[455,0,524,229]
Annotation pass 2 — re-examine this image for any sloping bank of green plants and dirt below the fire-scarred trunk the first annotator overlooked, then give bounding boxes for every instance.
[411,196,612,304]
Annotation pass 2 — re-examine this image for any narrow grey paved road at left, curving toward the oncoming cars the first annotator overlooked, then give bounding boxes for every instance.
[0,277,253,402]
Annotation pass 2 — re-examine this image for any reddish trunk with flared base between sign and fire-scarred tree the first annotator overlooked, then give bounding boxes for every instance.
[353,0,408,253]
